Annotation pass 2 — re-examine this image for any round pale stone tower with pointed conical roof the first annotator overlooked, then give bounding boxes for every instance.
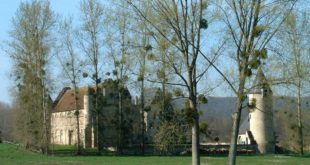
[249,68,275,154]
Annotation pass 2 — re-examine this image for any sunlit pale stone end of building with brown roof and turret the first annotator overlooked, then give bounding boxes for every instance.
[51,88,94,147]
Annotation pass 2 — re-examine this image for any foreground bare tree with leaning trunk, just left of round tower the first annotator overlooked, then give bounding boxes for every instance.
[216,0,296,165]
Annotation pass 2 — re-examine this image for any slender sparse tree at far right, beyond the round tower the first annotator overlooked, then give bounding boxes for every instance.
[272,10,310,155]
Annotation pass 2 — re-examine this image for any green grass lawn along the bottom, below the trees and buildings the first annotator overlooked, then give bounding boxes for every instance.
[0,144,310,165]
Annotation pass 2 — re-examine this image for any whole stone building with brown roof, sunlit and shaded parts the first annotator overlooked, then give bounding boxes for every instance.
[51,79,139,147]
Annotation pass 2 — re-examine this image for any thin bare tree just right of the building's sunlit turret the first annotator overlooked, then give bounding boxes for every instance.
[79,0,104,154]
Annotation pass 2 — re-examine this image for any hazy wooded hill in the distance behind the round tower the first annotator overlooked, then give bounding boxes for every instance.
[173,96,310,142]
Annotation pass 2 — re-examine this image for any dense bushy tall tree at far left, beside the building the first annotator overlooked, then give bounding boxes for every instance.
[8,0,55,154]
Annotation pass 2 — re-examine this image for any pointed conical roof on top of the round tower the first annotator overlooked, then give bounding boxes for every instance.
[250,67,271,94]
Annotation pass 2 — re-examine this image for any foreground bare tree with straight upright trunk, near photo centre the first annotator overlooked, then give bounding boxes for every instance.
[127,0,208,165]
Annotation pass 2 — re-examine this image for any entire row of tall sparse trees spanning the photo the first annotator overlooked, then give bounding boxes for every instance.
[3,0,309,165]
